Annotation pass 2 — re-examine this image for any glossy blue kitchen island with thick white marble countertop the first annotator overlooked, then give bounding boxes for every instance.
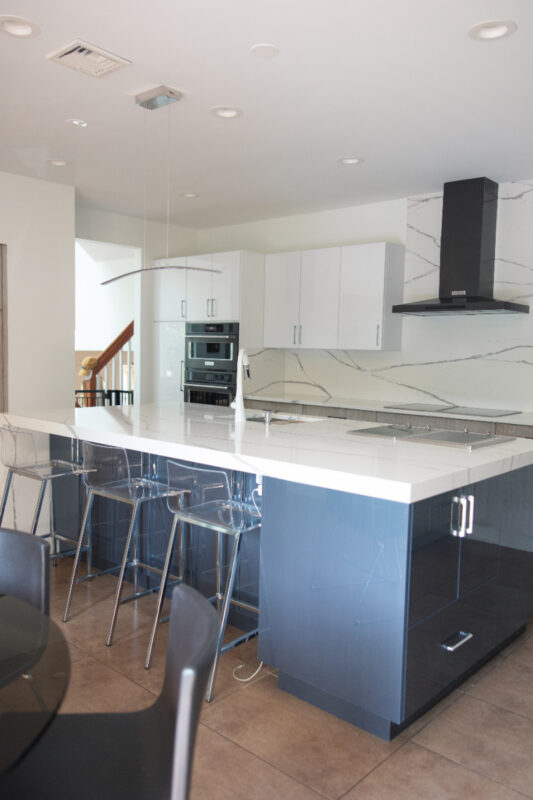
[4,404,533,739]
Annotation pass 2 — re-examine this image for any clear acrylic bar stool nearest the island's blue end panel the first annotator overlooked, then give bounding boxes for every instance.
[144,461,261,701]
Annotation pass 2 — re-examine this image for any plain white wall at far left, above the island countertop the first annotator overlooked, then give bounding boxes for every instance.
[0,172,74,411]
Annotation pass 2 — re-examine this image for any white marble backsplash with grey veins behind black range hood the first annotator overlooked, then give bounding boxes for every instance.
[246,176,533,411]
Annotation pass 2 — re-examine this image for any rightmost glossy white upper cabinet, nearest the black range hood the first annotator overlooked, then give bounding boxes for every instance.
[338,242,404,350]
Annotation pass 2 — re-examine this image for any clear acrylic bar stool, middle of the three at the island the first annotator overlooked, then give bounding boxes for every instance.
[63,442,179,645]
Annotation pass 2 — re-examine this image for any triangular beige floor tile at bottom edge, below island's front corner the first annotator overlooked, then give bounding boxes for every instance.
[343,744,523,800]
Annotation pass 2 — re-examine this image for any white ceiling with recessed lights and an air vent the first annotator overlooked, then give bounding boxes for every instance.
[0,0,533,227]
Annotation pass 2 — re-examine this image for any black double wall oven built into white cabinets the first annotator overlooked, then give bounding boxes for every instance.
[183,322,239,406]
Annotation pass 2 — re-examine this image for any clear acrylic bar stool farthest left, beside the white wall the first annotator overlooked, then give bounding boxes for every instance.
[0,427,85,558]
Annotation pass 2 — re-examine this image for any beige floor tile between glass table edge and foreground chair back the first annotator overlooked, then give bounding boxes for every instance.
[61,656,155,713]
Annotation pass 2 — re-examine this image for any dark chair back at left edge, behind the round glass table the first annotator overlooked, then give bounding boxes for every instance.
[0,528,50,614]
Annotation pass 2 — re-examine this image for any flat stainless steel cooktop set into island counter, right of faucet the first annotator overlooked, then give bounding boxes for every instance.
[348,425,515,450]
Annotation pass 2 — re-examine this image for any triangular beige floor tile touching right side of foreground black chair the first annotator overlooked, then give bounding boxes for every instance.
[191,725,320,800]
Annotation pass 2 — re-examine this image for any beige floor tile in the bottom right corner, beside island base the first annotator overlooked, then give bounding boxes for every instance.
[413,695,533,797]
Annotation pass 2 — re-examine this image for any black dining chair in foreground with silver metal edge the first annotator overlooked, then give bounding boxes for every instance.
[0,584,218,800]
